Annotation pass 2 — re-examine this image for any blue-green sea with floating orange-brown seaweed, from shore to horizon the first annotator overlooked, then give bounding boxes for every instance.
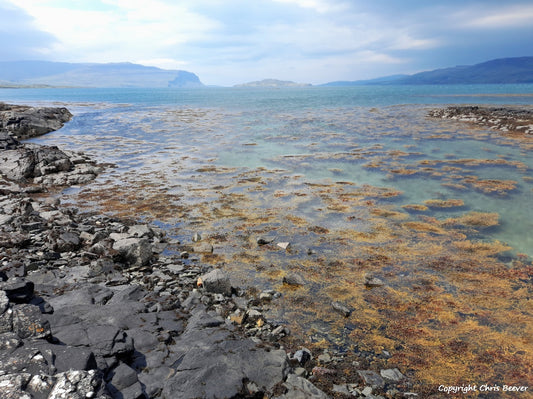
[0,84,533,394]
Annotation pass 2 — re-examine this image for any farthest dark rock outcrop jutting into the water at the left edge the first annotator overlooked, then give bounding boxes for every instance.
[0,103,72,141]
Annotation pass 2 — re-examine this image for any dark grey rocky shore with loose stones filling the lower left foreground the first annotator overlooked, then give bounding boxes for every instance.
[0,109,416,399]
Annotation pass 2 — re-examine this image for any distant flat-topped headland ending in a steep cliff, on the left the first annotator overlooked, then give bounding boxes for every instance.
[0,61,204,88]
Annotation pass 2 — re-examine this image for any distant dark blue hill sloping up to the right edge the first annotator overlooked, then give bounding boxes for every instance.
[323,57,533,86]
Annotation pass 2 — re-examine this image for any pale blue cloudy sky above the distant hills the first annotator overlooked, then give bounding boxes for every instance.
[0,0,533,86]
